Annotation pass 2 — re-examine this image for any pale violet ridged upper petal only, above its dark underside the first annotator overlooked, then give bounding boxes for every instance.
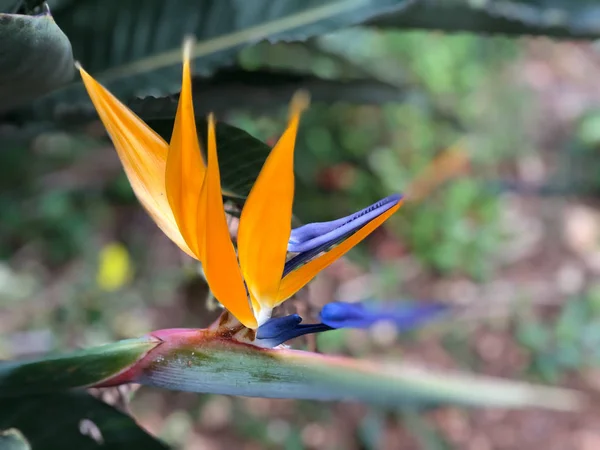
[288,194,402,253]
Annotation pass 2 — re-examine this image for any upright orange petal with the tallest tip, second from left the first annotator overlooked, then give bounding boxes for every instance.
[165,39,206,258]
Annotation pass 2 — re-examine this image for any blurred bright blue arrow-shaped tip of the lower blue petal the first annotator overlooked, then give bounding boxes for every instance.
[321,302,449,331]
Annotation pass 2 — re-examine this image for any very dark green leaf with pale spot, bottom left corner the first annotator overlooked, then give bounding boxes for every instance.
[0,392,168,450]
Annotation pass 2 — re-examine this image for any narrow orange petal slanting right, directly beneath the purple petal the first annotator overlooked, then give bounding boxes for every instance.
[277,201,402,304]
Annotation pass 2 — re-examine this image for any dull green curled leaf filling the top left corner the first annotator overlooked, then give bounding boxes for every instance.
[0,4,75,112]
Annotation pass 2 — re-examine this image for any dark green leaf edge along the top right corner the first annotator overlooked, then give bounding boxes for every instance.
[367,0,600,39]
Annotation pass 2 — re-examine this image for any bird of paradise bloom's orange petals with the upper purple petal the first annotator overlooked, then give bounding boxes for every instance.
[78,42,420,335]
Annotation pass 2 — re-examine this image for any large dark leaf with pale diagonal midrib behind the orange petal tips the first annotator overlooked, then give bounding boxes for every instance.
[31,0,409,111]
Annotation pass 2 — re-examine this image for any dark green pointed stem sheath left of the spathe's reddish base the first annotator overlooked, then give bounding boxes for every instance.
[0,337,159,396]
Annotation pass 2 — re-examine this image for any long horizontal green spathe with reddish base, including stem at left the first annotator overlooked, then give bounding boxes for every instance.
[0,329,582,410]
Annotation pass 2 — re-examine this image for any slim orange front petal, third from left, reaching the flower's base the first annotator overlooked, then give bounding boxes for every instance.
[199,116,258,328]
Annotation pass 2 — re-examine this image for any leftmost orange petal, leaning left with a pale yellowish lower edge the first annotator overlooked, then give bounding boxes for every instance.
[77,65,191,255]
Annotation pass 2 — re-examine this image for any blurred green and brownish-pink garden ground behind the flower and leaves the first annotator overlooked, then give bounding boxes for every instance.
[0,0,600,450]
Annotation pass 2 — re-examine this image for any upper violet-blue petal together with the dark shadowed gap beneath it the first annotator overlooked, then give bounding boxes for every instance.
[282,194,402,277]
